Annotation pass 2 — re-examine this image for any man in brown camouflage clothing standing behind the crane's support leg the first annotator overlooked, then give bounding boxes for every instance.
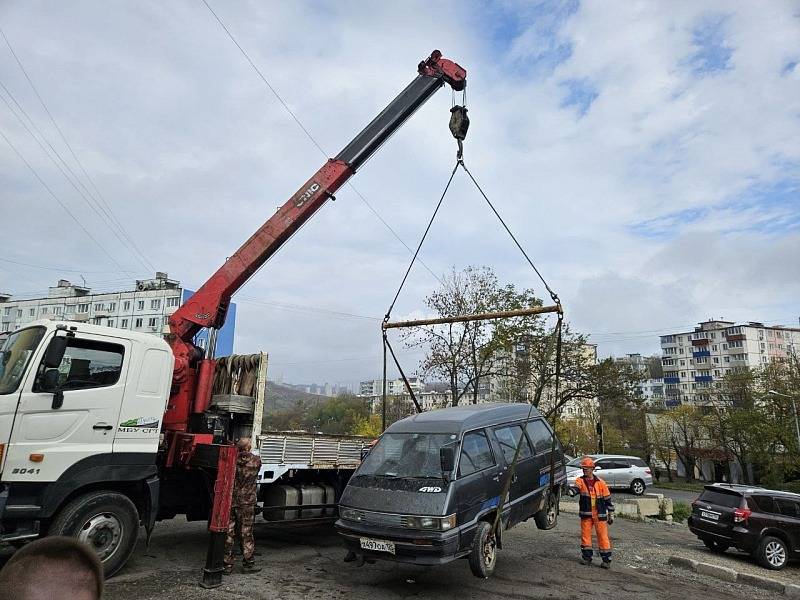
[224,438,261,575]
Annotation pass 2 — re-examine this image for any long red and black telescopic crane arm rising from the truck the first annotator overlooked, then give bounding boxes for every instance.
[164,50,467,432]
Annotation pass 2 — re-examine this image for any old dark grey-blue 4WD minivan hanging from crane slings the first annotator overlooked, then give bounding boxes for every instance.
[336,403,566,578]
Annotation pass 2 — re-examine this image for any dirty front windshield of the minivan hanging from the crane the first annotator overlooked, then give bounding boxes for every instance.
[358,433,458,479]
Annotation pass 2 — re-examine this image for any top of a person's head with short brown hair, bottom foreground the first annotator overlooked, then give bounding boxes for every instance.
[0,537,104,600]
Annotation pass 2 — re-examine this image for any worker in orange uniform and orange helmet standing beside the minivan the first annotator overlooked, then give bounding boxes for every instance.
[574,456,614,569]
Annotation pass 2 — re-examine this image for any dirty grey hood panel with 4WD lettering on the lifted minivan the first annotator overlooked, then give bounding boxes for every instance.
[339,476,447,516]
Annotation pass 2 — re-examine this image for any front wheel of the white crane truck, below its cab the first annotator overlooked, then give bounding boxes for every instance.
[47,491,139,578]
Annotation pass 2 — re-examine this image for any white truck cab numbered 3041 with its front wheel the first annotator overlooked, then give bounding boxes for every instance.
[0,320,174,573]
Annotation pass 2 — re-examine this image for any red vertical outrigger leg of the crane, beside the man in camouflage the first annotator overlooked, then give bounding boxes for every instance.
[200,446,236,588]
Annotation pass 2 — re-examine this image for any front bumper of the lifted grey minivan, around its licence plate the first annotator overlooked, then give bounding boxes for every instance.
[336,519,468,565]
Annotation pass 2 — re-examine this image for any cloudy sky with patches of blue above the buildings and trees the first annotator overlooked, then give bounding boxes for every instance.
[0,0,800,382]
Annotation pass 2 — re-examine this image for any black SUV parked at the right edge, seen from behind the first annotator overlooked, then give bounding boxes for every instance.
[689,483,800,570]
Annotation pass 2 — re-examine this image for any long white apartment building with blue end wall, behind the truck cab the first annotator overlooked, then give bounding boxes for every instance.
[0,272,236,356]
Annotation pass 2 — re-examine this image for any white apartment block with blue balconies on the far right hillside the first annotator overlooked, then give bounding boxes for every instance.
[661,319,800,407]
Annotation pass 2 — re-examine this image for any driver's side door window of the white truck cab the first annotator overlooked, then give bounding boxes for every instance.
[36,338,125,391]
